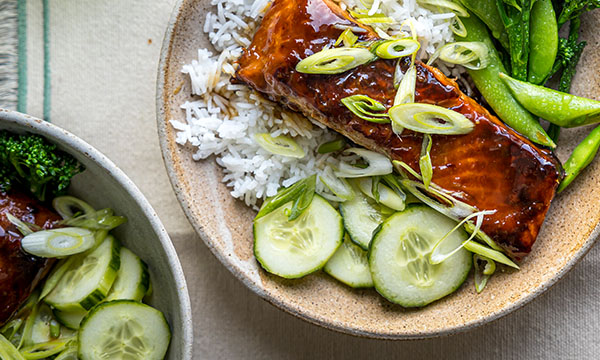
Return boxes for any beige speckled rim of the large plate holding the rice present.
[156,0,600,340]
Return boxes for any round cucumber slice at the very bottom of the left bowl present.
[79,300,171,360]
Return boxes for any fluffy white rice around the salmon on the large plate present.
[171,0,454,208]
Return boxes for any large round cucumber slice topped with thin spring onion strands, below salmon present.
[369,205,472,307]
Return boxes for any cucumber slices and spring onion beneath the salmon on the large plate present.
[254,147,518,307]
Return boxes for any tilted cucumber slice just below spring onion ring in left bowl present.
[45,236,121,311]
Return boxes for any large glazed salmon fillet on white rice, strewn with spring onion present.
[236,0,563,259]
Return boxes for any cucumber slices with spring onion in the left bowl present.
[0,196,171,360]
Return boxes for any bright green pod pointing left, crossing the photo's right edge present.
[500,73,600,128]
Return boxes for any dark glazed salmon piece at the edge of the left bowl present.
[0,191,61,325]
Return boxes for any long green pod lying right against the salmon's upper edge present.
[461,16,556,148]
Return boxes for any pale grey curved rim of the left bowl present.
[0,109,194,360]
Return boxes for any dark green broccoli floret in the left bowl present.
[0,131,83,201]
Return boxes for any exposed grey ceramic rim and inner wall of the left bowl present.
[0,109,193,360]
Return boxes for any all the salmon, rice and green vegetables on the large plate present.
[172,0,600,307]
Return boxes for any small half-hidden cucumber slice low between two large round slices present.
[323,234,373,288]
